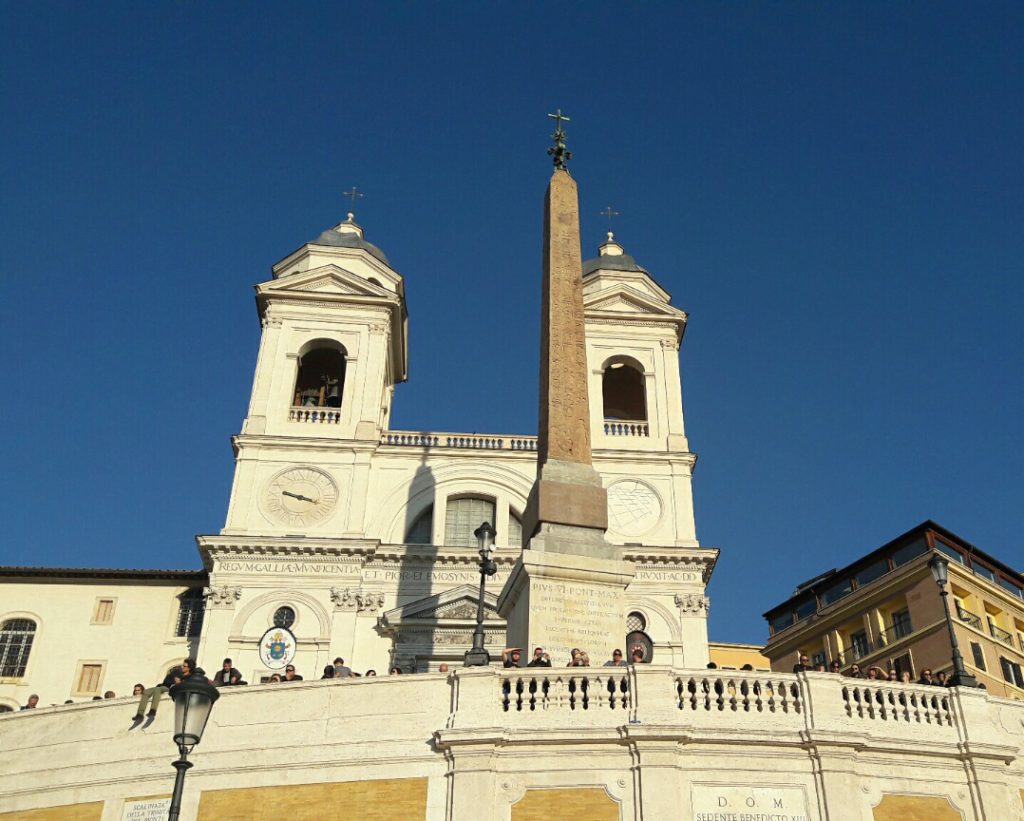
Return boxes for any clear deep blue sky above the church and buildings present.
[0,2,1024,642]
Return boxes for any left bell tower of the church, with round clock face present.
[222,213,409,536]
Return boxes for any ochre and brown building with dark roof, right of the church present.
[764,521,1024,699]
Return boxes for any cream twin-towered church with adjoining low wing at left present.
[0,210,718,709]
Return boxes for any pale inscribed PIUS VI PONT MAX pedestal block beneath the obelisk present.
[498,548,635,667]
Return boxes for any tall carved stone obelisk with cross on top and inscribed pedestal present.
[498,111,633,666]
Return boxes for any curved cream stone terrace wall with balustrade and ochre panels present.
[0,665,1024,821]
